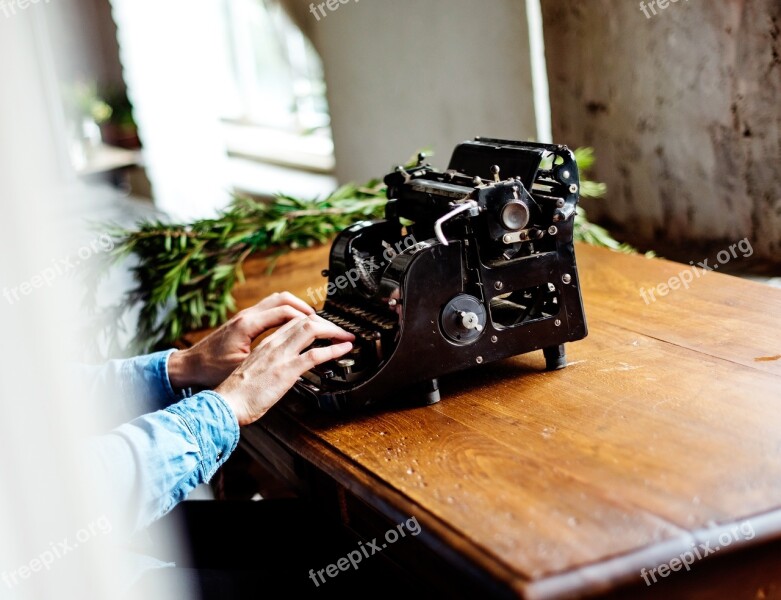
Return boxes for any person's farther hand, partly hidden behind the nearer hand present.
[168,292,315,389]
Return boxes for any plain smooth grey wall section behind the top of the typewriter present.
[288,0,536,181]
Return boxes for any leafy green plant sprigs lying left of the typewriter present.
[110,182,386,352]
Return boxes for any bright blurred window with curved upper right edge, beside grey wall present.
[222,0,333,173]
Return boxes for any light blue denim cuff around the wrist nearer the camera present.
[166,391,240,482]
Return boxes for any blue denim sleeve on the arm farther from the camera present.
[78,350,182,423]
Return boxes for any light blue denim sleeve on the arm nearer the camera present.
[87,391,239,533]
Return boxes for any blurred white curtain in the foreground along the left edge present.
[0,9,137,600]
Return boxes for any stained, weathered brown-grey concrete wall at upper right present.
[542,0,781,262]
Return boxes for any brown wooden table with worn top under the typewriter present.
[181,245,781,599]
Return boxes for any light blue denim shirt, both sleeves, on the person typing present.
[85,350,239,534]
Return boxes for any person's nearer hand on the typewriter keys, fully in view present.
[214,314,355,427]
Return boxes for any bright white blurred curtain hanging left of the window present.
[111,0,230,219]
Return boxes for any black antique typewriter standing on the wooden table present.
[294,138,586,410]
